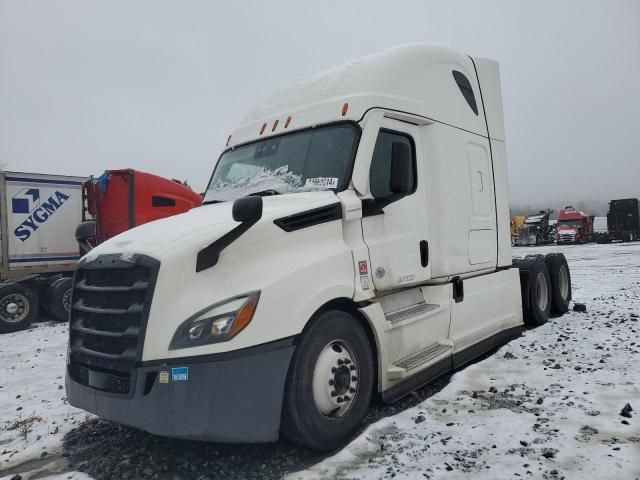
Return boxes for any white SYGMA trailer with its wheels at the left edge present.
[0,171,85,333]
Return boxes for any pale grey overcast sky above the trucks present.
[0,0,640,208]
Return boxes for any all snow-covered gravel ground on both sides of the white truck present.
[0,243,640,480]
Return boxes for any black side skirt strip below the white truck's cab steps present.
[380,326,523,403]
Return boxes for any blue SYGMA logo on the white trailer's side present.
[11,188,70,242]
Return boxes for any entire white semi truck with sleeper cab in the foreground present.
[66,45,571,449]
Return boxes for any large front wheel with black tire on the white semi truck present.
[281,310,374,450]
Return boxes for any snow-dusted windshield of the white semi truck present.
[204,123,359,204]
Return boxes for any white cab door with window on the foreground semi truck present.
[362,118,431,291]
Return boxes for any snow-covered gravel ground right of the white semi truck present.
[290,244,640,480]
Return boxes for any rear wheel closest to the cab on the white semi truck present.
[513,255,553,327]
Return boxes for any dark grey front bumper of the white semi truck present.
[65,339,295,443]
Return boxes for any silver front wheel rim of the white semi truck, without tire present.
[313,340,360,418]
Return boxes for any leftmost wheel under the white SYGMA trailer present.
[0,283,39,333]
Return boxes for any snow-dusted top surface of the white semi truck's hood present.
[83,191,338,261]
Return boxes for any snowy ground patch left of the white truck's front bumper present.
[0,322,89,479]
